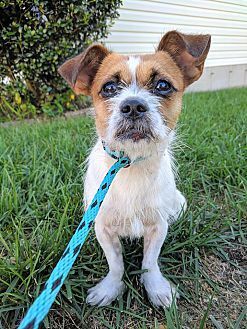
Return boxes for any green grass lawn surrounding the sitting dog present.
[0,89,247,329]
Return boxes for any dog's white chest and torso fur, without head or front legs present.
[84,141,185,237]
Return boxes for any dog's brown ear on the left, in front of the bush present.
[58,44,109,95]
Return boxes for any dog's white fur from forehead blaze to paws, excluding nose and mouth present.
[84,57,186,306]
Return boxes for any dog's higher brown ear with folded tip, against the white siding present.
[157,31,211,87]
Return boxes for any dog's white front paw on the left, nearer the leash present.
[86,276,124,306]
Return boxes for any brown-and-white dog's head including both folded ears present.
[59,31,210,155]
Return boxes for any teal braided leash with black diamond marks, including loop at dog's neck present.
[18,144,132,329]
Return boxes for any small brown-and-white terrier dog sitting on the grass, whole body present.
[59,31,211,306]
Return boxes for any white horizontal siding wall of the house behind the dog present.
[106,0,247,90]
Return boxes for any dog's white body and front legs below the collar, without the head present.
[85,141,185,306]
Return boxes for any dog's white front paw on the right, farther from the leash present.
[141,272,178,307]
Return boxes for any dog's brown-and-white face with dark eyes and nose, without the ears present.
[92,52,183,145]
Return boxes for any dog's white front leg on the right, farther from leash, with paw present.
[141,221,175,306]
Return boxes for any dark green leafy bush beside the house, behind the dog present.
[0,0,121,119]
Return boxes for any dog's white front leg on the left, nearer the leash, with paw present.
[86,218,124,306]
